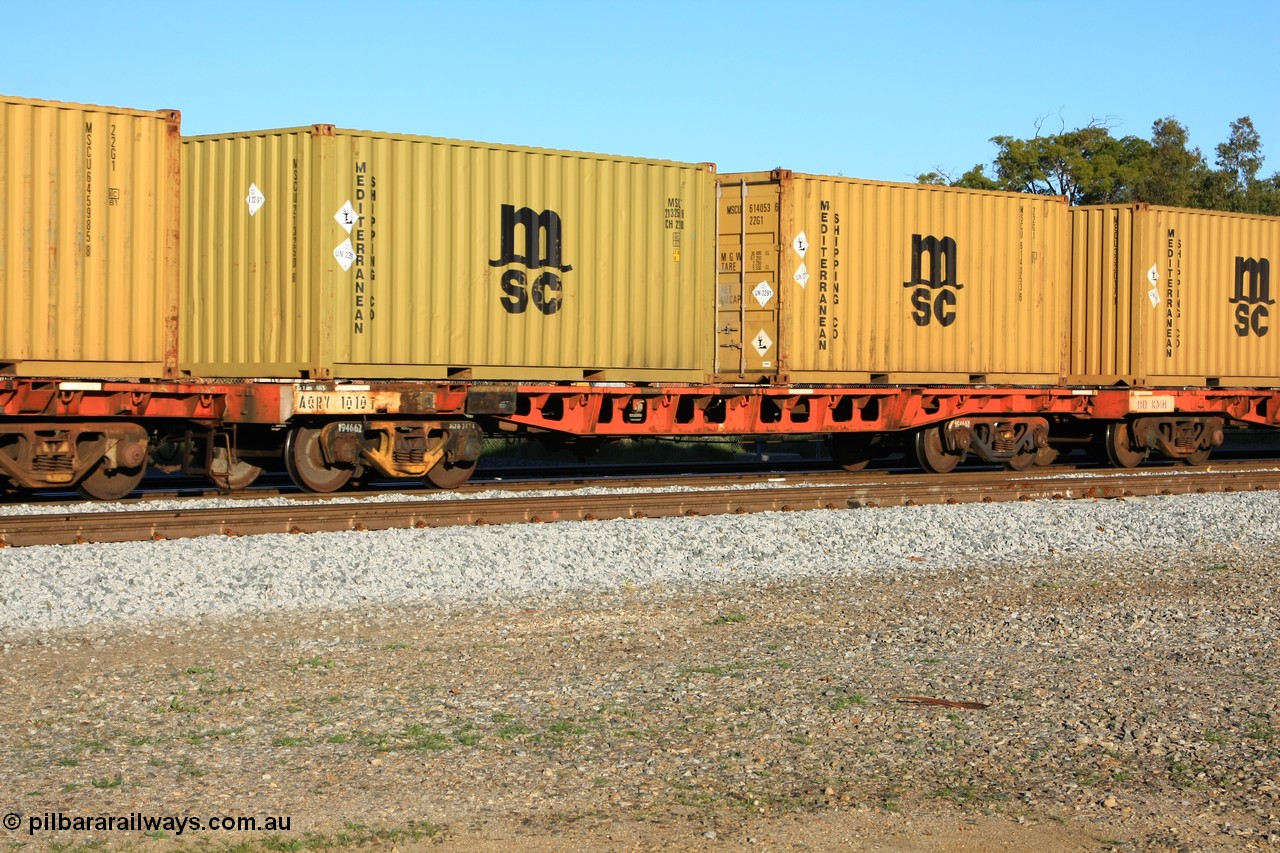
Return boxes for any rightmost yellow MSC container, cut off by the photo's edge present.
[1071,205,1280,387]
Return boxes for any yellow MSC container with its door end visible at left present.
[716,170,1069,384]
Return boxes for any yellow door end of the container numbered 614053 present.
[716,181,781,382]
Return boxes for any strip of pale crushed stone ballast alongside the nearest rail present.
[0,492,1264,635]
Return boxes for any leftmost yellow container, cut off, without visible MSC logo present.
[0,96,180,379]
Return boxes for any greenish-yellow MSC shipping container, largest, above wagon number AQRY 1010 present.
[182,124,716,380]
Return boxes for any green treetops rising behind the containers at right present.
[916,115,1280,215]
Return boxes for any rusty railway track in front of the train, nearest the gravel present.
[0,462,1280,547]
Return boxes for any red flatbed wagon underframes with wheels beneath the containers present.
[0,379,1280,500]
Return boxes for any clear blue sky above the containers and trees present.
[0,0,1280,181]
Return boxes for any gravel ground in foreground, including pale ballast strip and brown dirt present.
[0,493,1280,850]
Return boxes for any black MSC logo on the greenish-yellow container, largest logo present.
[489,205,573,316]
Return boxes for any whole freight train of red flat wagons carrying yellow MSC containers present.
[0,97,1280,500]
